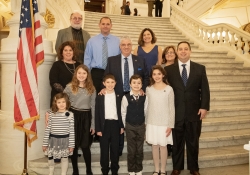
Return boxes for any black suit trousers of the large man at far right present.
[172,121,202,171]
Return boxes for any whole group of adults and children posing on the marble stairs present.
[43,12,210,175]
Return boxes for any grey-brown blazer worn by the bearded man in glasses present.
[55,26,90,52]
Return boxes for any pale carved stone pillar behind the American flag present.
[0,0,55,174]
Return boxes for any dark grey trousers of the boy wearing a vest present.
[126,123,146,173]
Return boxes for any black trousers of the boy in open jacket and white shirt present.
[100,120,120,175]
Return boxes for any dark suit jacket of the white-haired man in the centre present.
[104,54,149,96]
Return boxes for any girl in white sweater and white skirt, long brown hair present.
[146,65,175,175]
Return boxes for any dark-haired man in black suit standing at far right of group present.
[165,41,210,175]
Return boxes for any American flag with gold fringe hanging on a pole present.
[14,0,44,146]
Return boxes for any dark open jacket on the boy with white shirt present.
[95,94,124,132]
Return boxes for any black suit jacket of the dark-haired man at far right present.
[164,61,210,122]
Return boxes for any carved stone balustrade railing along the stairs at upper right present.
[170,0,250,66]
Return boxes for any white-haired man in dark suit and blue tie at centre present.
[102,36,149,155]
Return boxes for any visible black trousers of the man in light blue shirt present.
[91,68,105,94]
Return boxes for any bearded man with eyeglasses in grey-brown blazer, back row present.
[55,11,90,63]
